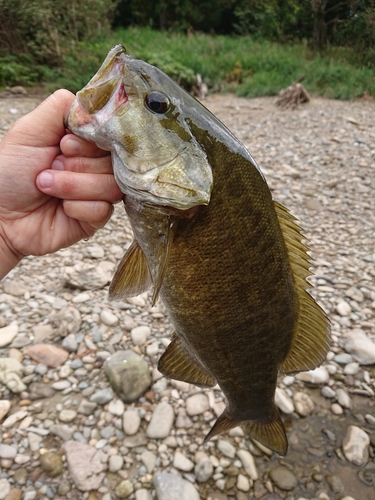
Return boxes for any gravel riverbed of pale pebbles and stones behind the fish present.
[0,95,375,500]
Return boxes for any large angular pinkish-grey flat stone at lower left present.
[64,441,107,491]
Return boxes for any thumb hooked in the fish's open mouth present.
[6,89,75,147]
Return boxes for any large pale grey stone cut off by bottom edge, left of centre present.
[154,472,200,500]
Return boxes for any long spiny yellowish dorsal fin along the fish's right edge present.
[274,202,330,373]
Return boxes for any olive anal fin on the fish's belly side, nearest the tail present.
[158,334,216,387]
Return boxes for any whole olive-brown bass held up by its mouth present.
[66,45,330,455]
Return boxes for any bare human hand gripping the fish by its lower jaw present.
[0,90,122,279]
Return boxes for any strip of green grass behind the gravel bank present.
[4,28,375,99]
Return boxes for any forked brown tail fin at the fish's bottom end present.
[204,406,288,456]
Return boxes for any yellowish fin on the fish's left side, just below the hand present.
[109,240,152,300]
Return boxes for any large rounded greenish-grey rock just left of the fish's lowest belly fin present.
[104,350,151,403]
